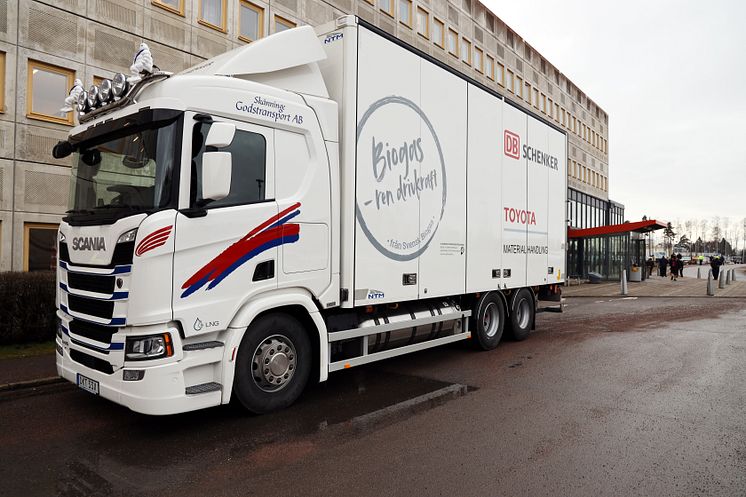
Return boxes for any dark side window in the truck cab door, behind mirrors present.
[192,126,267,209]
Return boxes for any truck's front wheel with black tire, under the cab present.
[233,313,313,414]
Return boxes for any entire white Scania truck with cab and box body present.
[54,16,567,414]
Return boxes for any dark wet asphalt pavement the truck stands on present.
[0,298,746,497]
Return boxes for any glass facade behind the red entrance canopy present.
[567,188,630,279]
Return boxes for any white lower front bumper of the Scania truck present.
[56,327,224,415]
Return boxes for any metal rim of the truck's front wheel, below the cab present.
[251,335,298,392]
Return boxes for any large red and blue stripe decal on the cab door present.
[181,202,300,298]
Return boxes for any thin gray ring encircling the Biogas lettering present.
[355,95,446,261]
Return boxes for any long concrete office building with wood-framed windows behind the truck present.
[0,0,618,271]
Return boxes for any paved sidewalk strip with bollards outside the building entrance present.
[562,265,746,298]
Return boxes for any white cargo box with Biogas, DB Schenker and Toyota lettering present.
[320,18,567,306]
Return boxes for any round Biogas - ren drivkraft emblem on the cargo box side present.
[355,96,447,261]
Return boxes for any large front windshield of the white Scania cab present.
[66,113,181,224]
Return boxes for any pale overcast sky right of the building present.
[483,0,746,229]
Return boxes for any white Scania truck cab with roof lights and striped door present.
[55,27,340,414]
